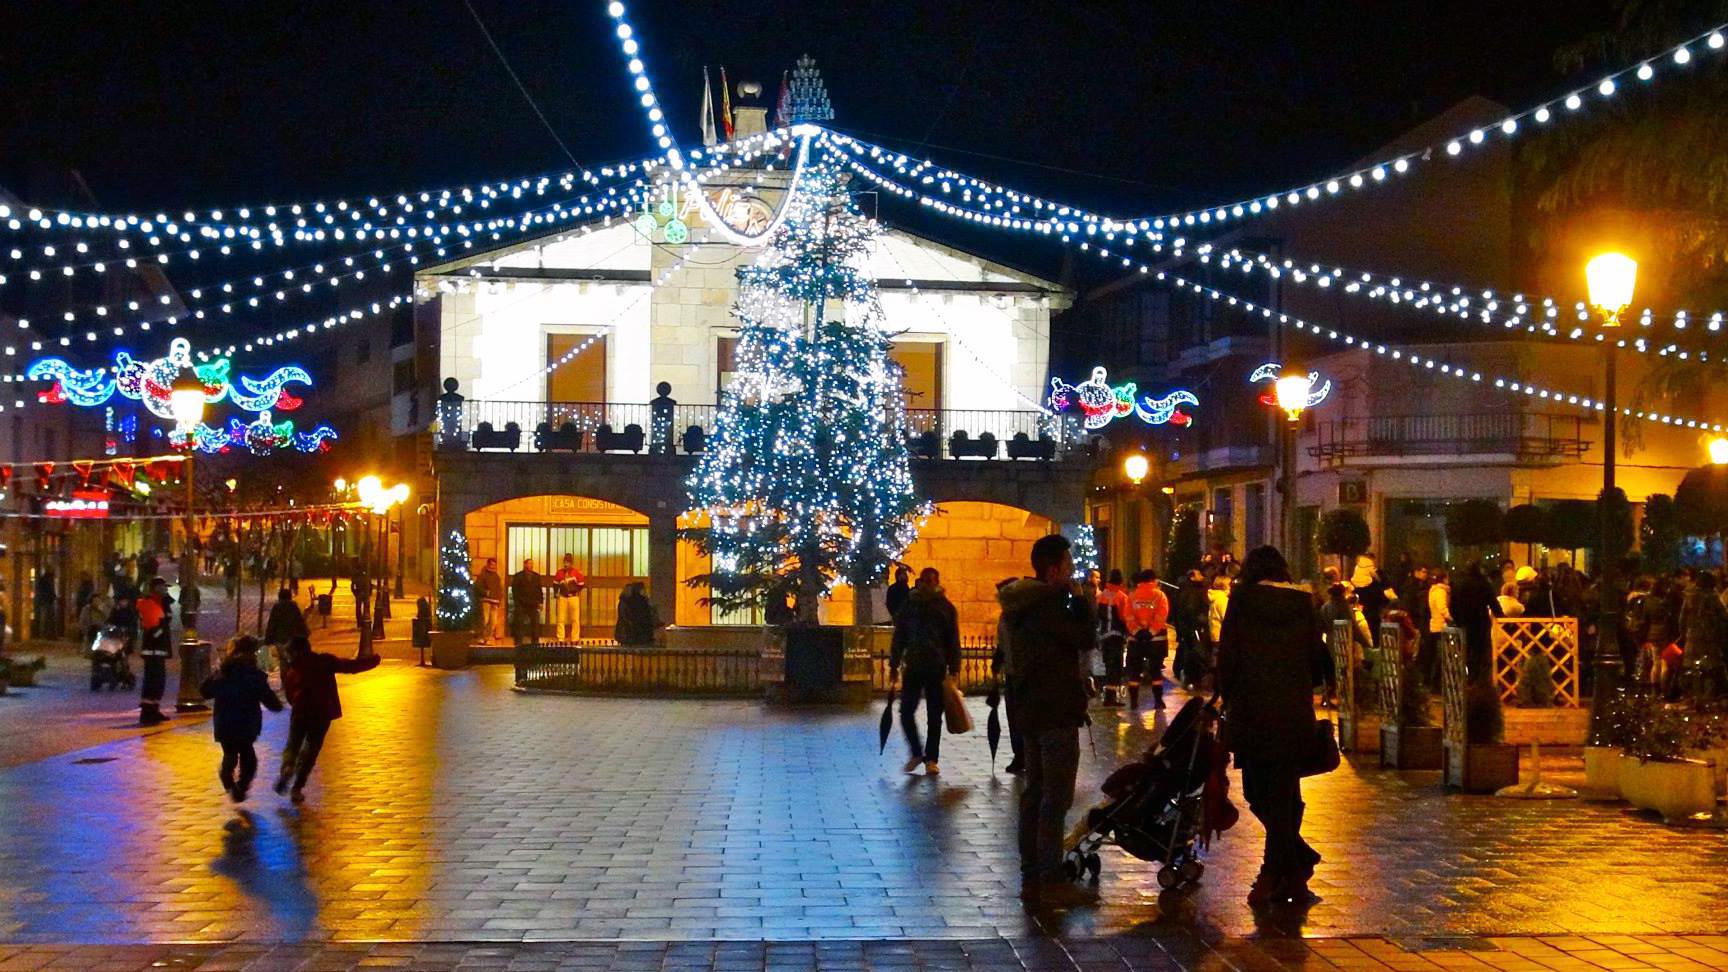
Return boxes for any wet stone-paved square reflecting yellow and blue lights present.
[0,662,1728,969]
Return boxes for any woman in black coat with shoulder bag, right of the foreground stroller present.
[1218,547,1325,908]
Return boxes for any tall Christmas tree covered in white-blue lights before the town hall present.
[684,163,928,621]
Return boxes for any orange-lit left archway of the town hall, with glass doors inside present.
[463,495,650,638]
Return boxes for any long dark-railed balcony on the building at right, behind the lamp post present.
[1308,412,1590,467]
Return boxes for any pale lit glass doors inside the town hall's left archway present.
[505,522,648,638]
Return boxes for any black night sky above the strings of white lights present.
[0,0,1638,223]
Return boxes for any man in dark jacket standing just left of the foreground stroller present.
[997,534,1092,901]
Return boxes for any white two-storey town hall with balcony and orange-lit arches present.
[415,154,1092,636]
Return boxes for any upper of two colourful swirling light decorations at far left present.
[26,337,313,420]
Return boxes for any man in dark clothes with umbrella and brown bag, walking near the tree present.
[888,567,961,777]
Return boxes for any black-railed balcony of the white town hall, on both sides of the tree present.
[437,393,1089,462]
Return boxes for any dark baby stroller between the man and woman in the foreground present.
[1063,695,1239,889]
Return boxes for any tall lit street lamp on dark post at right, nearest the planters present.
[1585,253,1638,745]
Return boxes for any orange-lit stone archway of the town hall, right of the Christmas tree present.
[902,500,1058,638]
